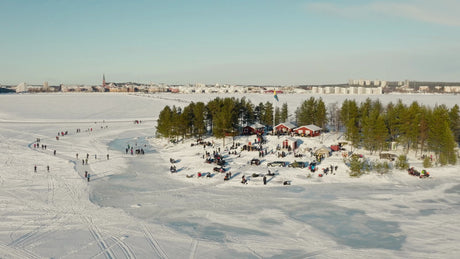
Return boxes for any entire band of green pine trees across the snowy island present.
[157,97,460,165]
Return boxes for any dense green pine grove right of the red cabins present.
[339,99,460,165]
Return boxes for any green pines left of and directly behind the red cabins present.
[157,97,327,138]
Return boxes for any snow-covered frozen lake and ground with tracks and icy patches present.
[0,94,460,258]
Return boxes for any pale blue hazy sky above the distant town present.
[0,0,460,85]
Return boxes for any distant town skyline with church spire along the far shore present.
[0,76,460,95]
